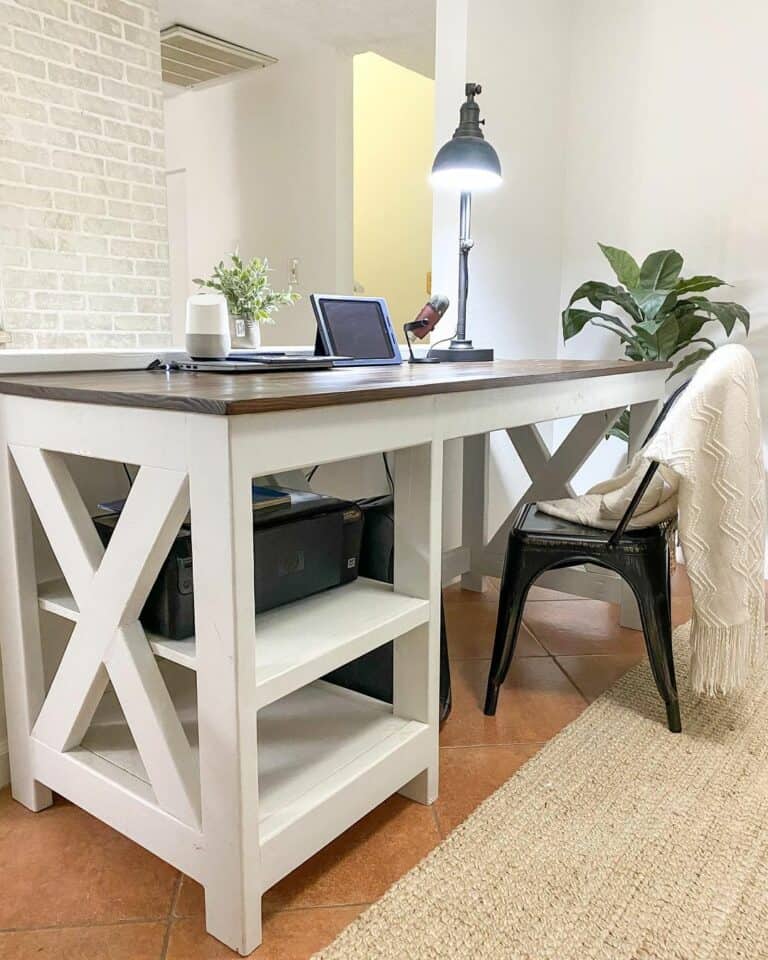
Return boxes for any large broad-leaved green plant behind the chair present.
[562,243,749,440]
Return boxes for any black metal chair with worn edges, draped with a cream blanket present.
[485,381,690,733]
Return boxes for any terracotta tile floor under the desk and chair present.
[0,569,690,960]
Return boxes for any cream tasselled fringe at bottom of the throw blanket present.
[690,602,766,697]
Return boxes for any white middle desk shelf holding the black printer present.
[38,578,429,708]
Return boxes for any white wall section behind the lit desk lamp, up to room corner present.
[433,0,569,546]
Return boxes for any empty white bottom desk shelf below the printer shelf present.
[75,680,433,889]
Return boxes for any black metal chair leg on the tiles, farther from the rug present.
[483,539,539,717]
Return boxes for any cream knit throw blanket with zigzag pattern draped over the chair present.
[538,344,765,696]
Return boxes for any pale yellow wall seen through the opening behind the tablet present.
[353,53,434,339]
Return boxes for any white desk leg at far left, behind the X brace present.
[0,441,53,811]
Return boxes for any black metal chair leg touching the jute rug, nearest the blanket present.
[620,564,682,733]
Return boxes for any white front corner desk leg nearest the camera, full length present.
[188,417,262,955]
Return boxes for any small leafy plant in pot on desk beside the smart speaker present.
[193,250,300,347]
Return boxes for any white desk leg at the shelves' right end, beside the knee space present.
[394,441,443,803]
